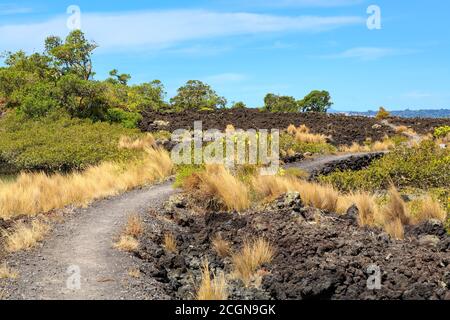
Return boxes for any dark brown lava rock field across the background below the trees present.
[140,109,395,145]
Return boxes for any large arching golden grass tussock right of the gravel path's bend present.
[183,165,250,211]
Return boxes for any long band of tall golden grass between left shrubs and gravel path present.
[0,149,173,219]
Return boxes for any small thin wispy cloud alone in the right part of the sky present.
[322,47,417,61]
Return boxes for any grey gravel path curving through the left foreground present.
[5,183,175,300]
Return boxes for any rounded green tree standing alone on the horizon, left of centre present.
[170,80,227,111]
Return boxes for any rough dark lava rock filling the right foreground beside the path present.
[137,194,450,300]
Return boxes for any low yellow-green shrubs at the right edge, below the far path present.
[319,141,450,191]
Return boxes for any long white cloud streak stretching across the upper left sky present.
[0,10,364,50]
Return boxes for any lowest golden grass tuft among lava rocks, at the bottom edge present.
[196,260,228,300]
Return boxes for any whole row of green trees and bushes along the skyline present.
[0,30,332,128]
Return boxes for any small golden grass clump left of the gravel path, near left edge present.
[4,220,50,252]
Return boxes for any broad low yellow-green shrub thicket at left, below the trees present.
[0,113,140,172]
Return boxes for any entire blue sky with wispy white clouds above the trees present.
[0,0,450,110]
